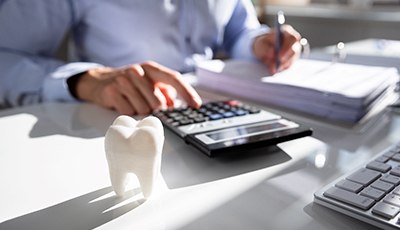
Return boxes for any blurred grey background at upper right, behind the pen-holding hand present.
[253,0,400,48]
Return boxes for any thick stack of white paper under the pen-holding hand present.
[196,60,399,123]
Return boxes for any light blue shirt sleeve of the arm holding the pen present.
[224,0,270,60]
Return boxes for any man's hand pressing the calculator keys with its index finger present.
[76,62,201,115]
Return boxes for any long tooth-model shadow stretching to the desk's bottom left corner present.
[0,187,144,230]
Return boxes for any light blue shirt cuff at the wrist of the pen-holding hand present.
[232,25,270,61]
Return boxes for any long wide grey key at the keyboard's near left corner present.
[324,187,375,210]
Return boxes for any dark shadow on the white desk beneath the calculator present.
[161,130,292,189]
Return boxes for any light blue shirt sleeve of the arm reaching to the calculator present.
[0,0,98,108]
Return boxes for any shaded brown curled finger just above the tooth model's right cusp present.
[115,74,151,114]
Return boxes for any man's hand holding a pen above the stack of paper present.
[253,25,301,74]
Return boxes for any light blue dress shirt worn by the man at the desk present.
[0,0,268,108]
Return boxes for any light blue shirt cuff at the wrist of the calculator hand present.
[43,62,102,102]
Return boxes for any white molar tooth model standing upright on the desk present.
[104,115,164,199]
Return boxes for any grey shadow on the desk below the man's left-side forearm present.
[0,103,118,139]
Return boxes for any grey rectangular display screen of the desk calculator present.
[206,122,286,141]
